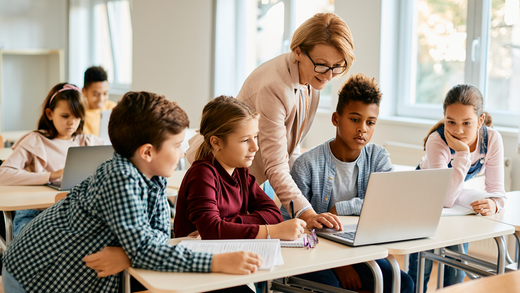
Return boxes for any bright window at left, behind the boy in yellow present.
[69,0,132,92]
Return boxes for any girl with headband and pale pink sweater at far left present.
[0,83,103,236]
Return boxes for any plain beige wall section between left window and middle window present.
[132,0,214,128]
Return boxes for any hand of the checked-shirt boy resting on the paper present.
[211,251,262,275]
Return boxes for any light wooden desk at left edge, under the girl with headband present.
[0,186,60,251]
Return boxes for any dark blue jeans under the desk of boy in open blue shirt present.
[296,259,414,293]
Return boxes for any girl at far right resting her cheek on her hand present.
[408,84,505,292]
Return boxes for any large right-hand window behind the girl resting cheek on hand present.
[397,0,520,126]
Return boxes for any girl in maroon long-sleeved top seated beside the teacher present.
[174,96,305,240]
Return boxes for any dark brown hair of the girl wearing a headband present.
[36,82,85,139]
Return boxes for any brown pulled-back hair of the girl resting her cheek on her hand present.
[423,84,493,150]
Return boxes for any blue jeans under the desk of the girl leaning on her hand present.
[408,243,468,293]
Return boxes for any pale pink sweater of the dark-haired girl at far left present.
[0,131,103,185]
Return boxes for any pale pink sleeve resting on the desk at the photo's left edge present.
[0,147,51,185]
